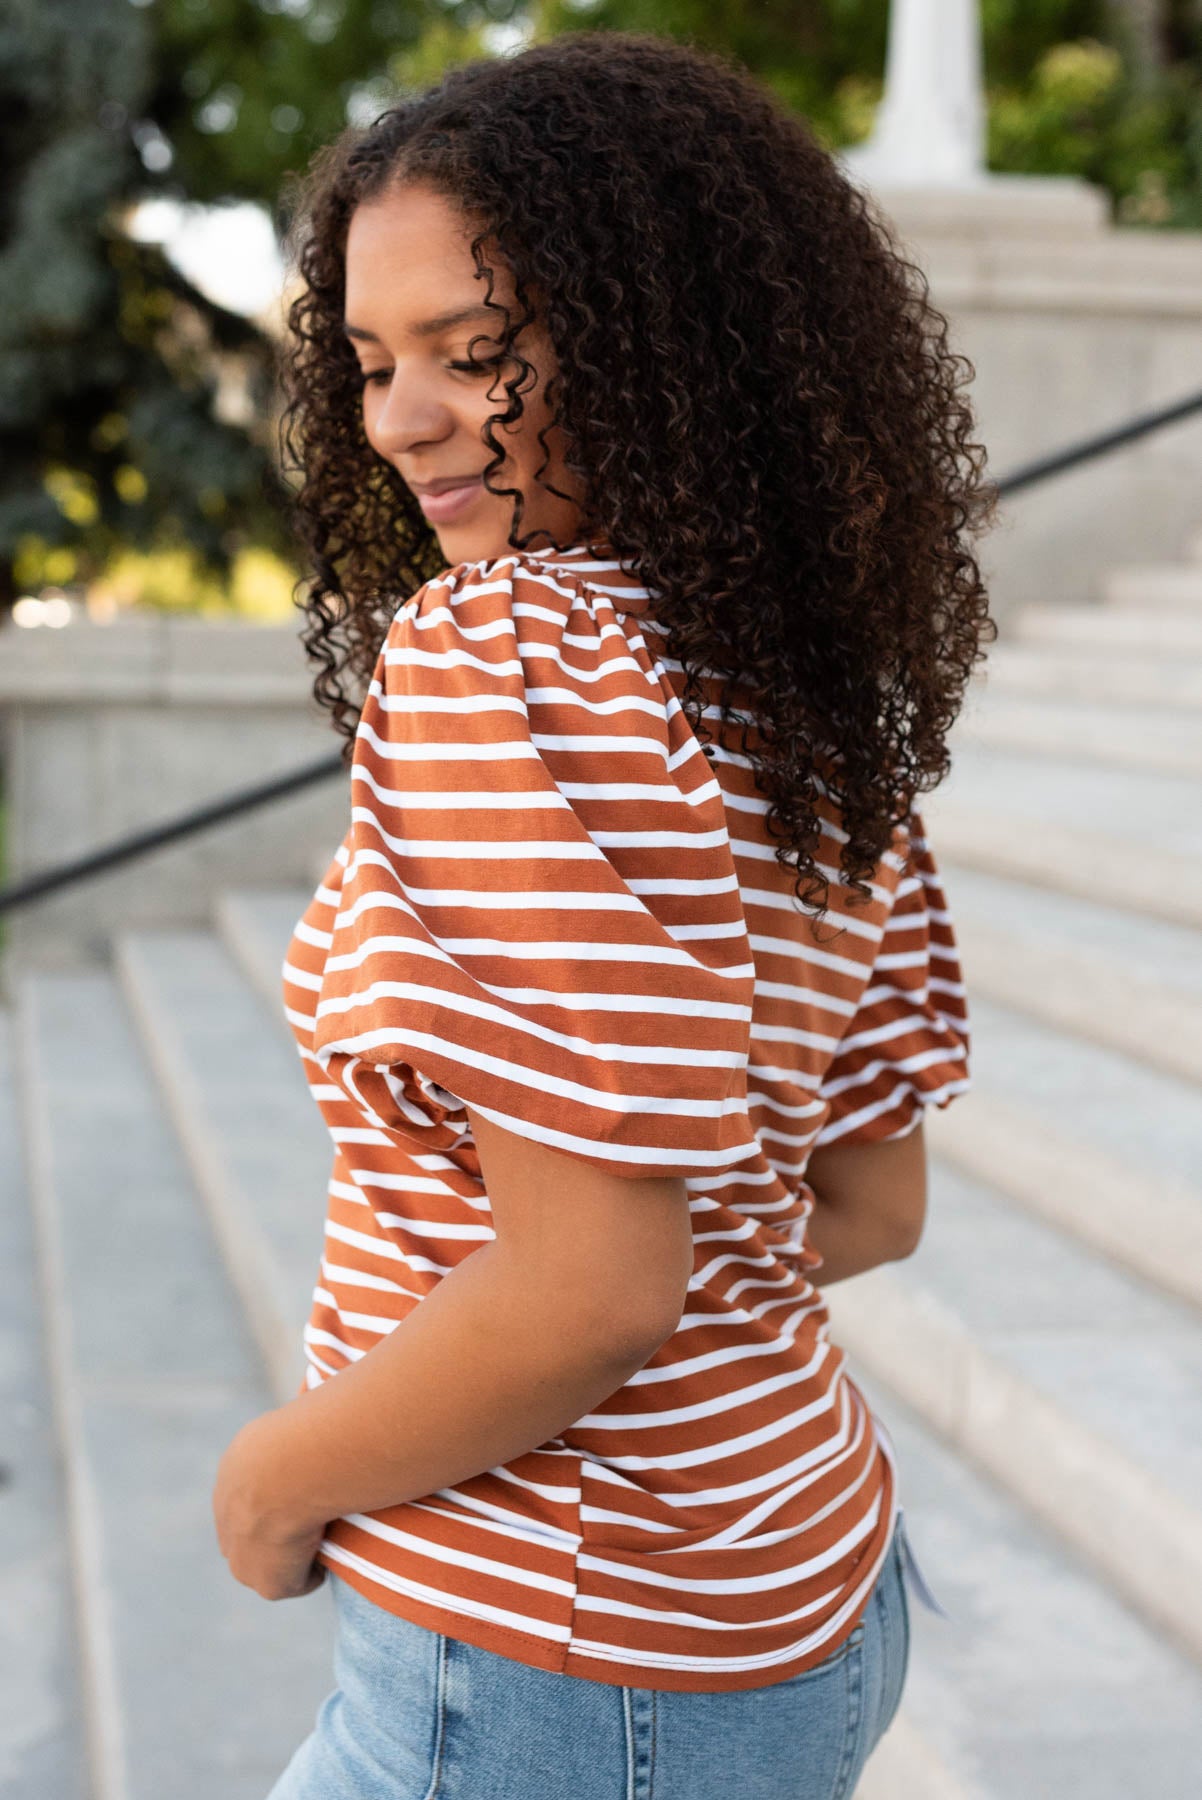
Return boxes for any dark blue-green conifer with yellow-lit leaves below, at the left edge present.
[0,0,296,607]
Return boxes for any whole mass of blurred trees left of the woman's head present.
[0,0,515,608]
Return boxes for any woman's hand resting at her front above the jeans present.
[212,1413,326,1600]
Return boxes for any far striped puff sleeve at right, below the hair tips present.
[815,810,972,1145]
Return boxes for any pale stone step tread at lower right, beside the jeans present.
[849,1368,1202,1800]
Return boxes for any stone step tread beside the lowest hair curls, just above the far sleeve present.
[923,806,1202,931]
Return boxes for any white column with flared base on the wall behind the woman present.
[840,0,986,187]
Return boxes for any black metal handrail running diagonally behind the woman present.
[0,378,1202,916]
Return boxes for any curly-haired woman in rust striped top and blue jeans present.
[214,32,991,1800]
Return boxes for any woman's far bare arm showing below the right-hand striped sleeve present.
[806,1120,927,1287]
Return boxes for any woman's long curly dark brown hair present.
[281,31,997,916]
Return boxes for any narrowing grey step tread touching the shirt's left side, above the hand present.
[115,929,333,1402]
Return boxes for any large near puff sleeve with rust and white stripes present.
[313,554,754,1177]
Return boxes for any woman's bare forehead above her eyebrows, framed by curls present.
[345,185,513,328]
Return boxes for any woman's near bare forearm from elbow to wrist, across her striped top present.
[256,1240,653,1525]
